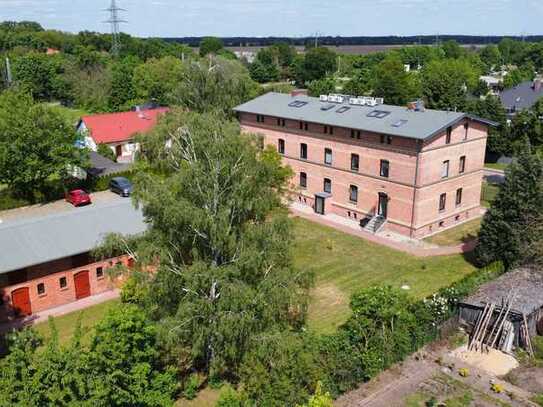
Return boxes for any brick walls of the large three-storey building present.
[239,112,487,238]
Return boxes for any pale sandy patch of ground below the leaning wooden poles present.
[451,345,519,376]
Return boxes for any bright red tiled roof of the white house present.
[81,107,169,144]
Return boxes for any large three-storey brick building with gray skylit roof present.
[235,93,493,238]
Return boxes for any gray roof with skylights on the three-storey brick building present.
[234,92,474,140]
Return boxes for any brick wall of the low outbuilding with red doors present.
[0,254,132,321]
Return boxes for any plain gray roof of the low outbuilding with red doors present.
[0,199,147,273]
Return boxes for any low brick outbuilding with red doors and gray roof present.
[0,200,146,321]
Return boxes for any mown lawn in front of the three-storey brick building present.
[293,218,475,333]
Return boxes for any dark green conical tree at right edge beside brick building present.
[475,140,543,267]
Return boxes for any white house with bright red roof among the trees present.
[77,107,169,162]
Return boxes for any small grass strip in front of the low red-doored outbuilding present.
[34,300,119,344]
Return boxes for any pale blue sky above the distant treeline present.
[0,0,543,37]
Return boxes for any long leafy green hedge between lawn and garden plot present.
[240,263,505,407]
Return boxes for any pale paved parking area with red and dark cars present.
[0,191,130,223]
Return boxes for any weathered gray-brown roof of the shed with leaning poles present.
[462,268,543,316]
